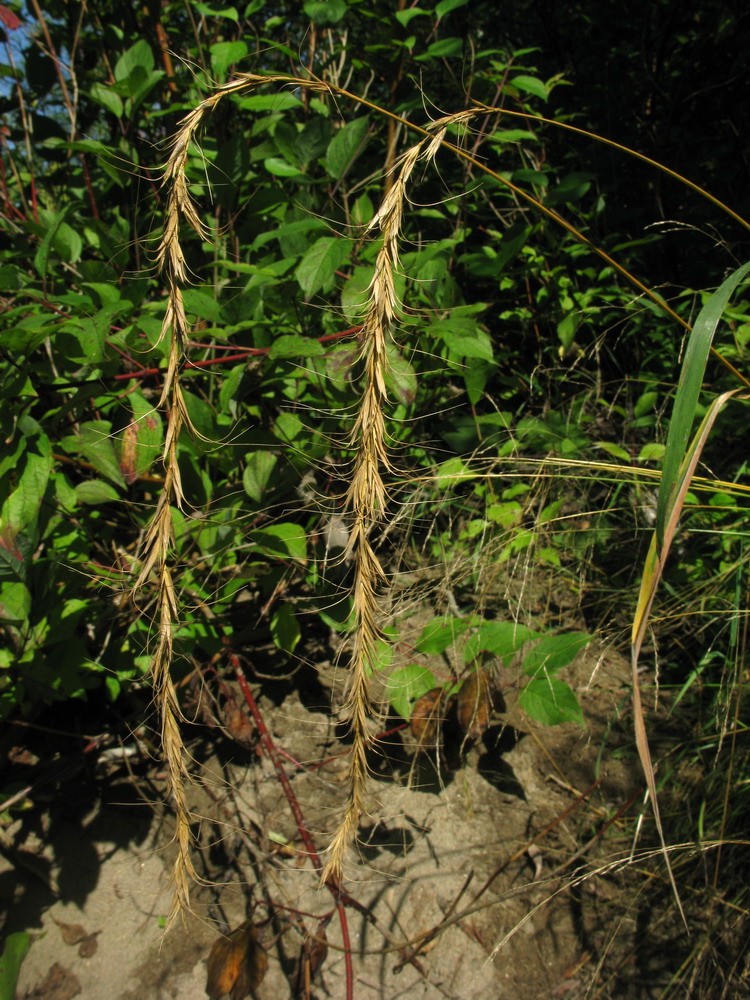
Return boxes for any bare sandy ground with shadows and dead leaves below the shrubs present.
[0,640,638,1000]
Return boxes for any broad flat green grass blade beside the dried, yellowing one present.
[656,262,750,547]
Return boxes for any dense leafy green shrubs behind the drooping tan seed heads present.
[0,0,750,995]
